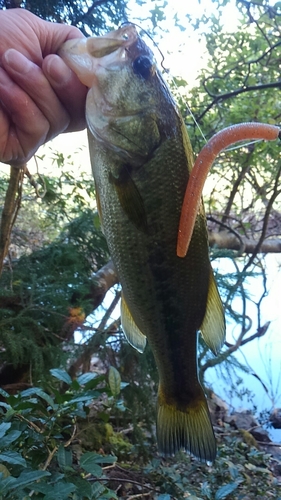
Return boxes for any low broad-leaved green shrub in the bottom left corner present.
[0,369,121,500]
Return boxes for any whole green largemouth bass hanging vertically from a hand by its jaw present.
[59,24,225,464]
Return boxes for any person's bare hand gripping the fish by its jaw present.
[0,9,87,166]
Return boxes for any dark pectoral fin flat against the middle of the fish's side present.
[109,165,147,232]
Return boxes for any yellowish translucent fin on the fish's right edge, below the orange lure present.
[200,267,225,354]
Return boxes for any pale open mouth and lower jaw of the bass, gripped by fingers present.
[58,24,139,87]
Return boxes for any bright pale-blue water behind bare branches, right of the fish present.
[206,254,281,443]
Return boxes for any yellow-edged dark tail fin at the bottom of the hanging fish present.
[156,384,214,465]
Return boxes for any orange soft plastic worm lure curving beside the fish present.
[177,123,281,257]
